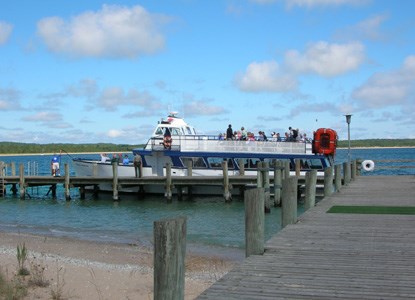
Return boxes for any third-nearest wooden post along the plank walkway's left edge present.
[281,177,298,227]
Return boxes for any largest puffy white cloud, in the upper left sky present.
[37,5,165,58]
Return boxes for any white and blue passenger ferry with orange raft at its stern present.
[73,112,337,193]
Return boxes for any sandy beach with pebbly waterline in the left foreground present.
[0,232,237,300]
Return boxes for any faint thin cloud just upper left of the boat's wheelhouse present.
[98,87,161,111]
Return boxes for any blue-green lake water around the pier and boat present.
[0,148,415,257]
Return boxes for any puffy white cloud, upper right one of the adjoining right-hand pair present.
[285,41,365,77]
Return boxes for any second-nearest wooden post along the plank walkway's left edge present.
[244,188,265,257]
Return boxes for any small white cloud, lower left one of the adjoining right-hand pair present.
[235,61,297,92]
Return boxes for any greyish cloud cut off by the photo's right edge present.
[352,55,415,108]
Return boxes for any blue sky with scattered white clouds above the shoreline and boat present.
[0,0,415,144]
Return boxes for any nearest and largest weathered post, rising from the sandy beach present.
[154,217,186,300]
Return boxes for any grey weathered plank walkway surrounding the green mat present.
[198,176,415,299]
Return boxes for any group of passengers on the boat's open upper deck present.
[219,124,310,142]
